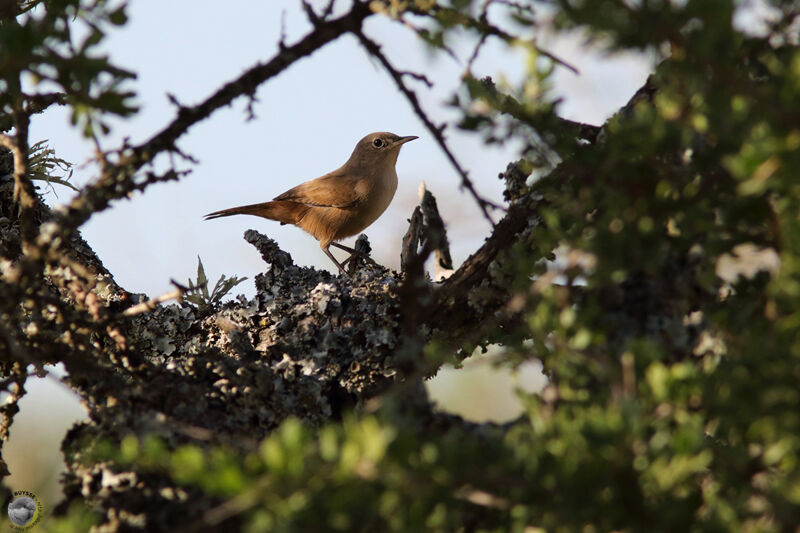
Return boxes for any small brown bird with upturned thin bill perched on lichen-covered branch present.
[205,131,417,276]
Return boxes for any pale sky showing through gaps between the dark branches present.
[5,0,664,508]
